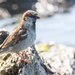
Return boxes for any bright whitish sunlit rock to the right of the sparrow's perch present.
[38,42,75,75]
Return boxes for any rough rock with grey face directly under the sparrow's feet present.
[0,47,46,75]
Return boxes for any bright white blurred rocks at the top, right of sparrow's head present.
[35,0,75,17]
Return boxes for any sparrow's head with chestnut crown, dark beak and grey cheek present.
[22,10,39,29]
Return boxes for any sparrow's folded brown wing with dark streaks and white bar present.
[1,27,27,48]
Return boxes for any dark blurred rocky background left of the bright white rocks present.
[0,0,36,18]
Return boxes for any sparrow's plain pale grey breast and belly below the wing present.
[13,30,36,52]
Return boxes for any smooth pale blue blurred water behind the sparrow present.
[0,6,75,46]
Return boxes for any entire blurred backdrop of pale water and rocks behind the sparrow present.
[0,0,75,46]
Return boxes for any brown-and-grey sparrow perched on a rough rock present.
[0,10,39,62]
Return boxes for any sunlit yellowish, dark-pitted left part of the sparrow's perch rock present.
[0,53,19,75]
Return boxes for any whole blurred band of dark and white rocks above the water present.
[0,0,75,18]
